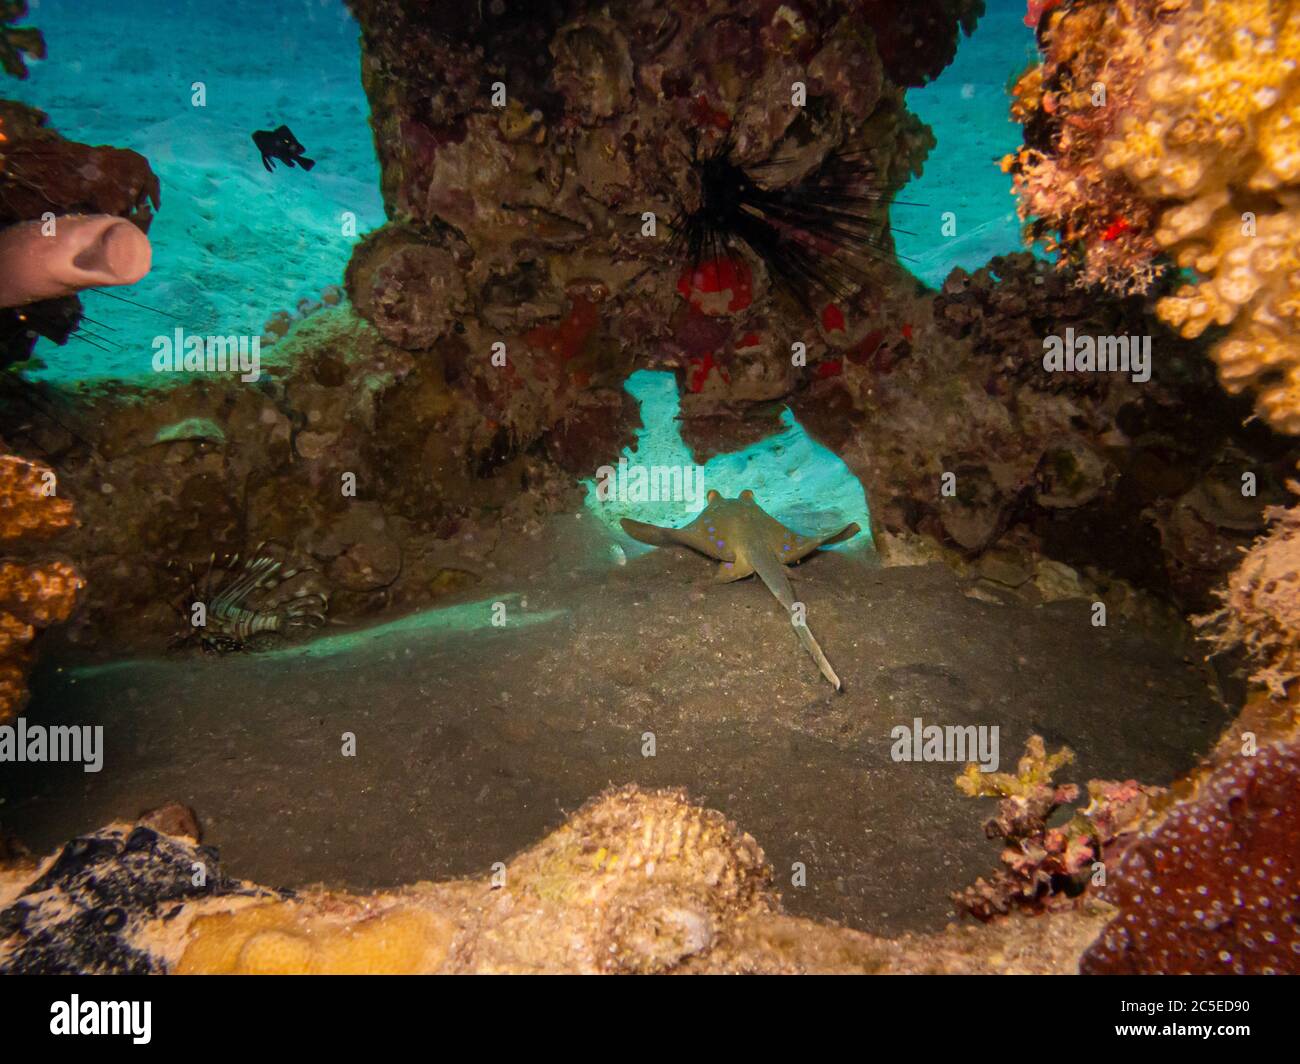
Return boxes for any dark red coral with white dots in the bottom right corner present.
[1080,738,1300,974]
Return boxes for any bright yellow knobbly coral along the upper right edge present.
[1104,0,1300,433]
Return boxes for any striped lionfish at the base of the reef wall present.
[172,542,329,653]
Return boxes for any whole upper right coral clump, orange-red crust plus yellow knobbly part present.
[1004,0,1300,434]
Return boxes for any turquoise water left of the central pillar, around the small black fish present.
[10,0,384,381]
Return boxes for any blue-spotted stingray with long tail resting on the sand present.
[621,490,861,691]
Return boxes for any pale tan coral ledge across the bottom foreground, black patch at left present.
[0,787,1104,974]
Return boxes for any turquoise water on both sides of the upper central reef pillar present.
[3,0,1034,381]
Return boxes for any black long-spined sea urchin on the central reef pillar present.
[670,137,905,313]
